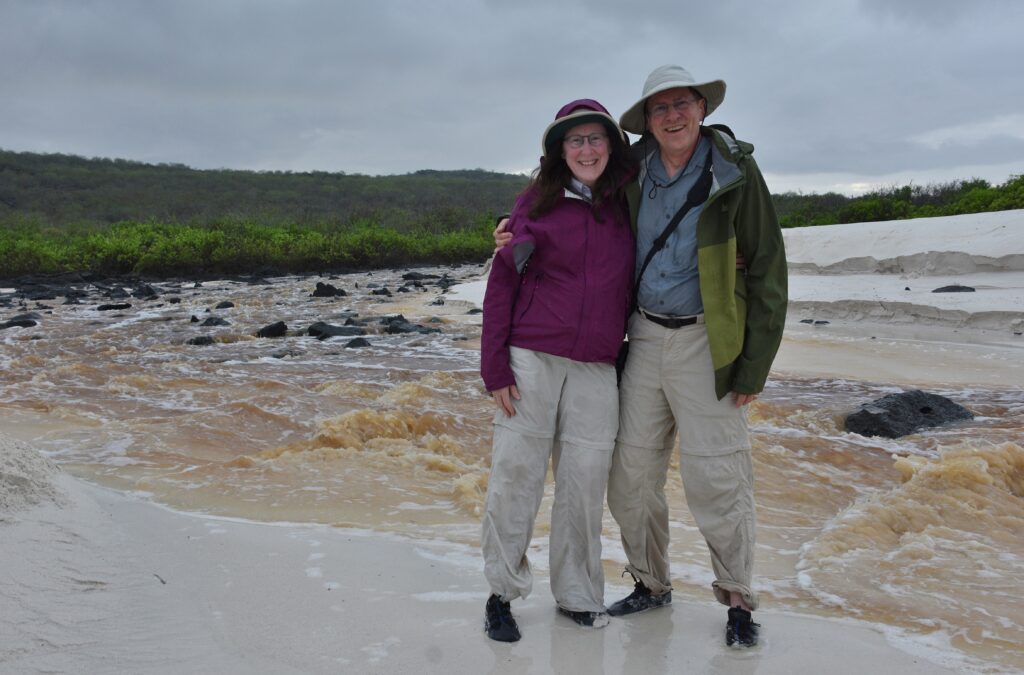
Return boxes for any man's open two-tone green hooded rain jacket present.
[626,127,787,398]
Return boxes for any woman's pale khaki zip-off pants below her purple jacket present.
[482,347,618,611]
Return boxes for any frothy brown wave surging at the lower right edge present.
[797,442,1024,658]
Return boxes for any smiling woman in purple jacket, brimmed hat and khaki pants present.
[480,99,635,642]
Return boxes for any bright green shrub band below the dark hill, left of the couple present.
[0,217,494,278]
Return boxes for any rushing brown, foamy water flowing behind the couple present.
[0,267,1024,670]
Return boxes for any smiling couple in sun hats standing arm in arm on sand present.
[480,66,786,646]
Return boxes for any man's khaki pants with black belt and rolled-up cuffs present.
[608,314,758,609]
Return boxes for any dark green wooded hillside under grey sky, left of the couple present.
[0,150,527,228]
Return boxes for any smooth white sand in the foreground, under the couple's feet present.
[0,446,952,675]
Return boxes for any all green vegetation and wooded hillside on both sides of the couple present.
[0,150,1024,279]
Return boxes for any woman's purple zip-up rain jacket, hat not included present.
[480,191,634,391]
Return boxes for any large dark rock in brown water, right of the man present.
[846,389,974,438]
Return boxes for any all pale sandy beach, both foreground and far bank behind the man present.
[0,211,1024,674]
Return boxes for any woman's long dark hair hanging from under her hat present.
[526,126,637,222]
